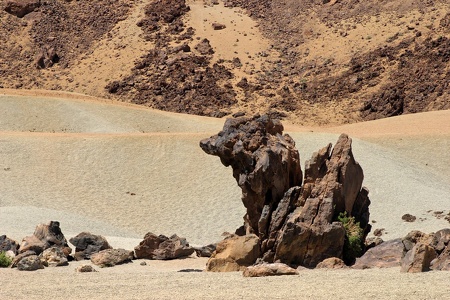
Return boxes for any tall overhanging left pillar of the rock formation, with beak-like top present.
[200,115,302,235]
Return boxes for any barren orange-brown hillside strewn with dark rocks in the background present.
[0,0,450,125]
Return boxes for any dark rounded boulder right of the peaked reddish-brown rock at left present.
[69,232,112,260]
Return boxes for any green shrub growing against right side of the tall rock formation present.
[338,212,364,265]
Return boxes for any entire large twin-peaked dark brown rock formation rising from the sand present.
[200,115,371,267]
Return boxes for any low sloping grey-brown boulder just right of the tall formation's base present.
[352,239,404,269]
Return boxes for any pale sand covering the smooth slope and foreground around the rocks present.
[0,94,450,299]
